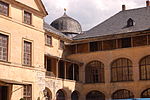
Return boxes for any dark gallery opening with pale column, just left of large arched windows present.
[69,64,79,81]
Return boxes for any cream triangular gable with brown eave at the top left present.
[15,0,47,15]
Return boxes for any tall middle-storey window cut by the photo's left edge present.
[0,34,8,61]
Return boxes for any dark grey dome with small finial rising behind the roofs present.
[51,9,82,38]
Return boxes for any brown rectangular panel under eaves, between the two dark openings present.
[103,40,116,50]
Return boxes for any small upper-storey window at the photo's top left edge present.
[0,1,9,16]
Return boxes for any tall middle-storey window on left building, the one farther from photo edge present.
[24,41,32,66]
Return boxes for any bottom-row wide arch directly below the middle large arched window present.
[112,89,134,99]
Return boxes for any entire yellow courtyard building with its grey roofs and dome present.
[0,0,150,100]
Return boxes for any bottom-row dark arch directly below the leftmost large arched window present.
[86,91,105,100]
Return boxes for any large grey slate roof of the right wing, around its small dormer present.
[73,7,150,40]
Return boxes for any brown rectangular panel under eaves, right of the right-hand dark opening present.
[133,35,147,46]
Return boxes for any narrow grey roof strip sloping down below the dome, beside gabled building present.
[44,22,71,40]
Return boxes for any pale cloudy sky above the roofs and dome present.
[42,0,146,31]
